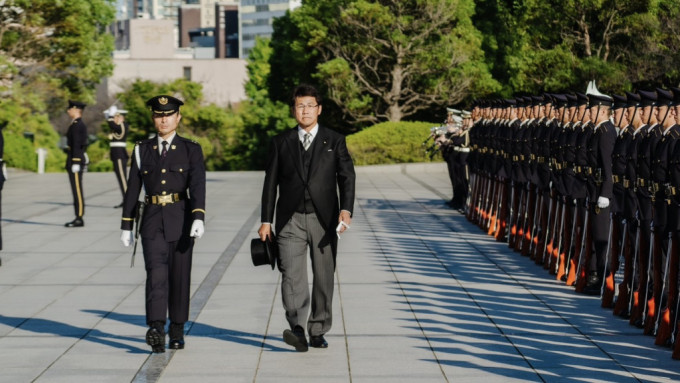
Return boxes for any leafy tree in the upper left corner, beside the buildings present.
[0,0,115,111]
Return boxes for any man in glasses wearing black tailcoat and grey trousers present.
[258,85,355,351]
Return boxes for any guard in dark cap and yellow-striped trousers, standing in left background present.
[64,100,87,227]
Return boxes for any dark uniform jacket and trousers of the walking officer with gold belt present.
[121,135,205,325]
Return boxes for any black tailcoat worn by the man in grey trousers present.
[261,126,355,235]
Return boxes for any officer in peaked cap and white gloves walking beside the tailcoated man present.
[121,96,205,352]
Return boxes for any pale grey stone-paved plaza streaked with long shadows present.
[0,163,680,383]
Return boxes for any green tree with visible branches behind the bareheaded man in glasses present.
[291,0,498,124]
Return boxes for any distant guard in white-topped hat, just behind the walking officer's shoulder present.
[104,105,130,208]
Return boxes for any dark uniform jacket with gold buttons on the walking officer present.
[121,135,205,242]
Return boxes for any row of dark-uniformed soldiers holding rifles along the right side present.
[464,82,680,359]
